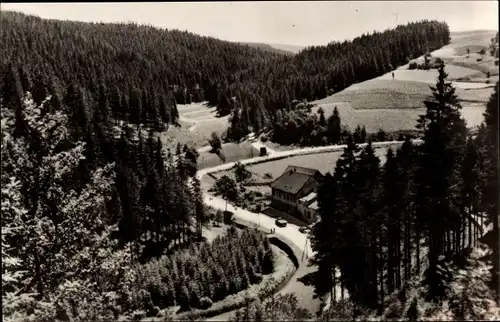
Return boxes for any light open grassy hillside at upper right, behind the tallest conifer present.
[313,31,498,132]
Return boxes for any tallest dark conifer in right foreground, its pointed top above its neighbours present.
[416,65,466,299]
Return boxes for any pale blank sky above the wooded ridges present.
[1,0,498,46]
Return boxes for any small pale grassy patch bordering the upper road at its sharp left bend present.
[198,142,259,169]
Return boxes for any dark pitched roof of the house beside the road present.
[271,165,321,195]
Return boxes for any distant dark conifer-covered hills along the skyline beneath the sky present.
[0,12,449,139]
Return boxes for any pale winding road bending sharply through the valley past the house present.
[196,140,422,320]
